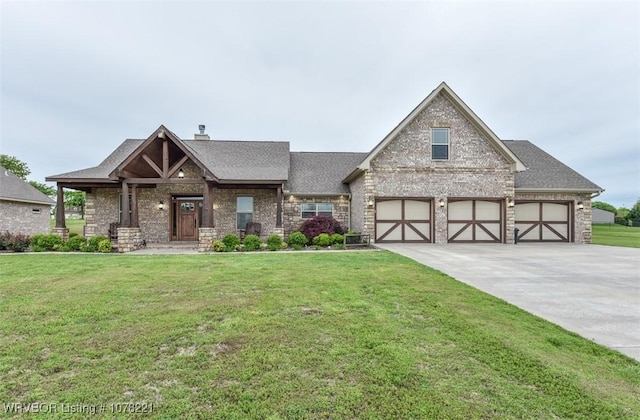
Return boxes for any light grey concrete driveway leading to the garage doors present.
[376,243,640,360]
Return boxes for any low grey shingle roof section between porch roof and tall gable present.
[289,152,367,194]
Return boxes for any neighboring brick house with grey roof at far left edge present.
[0,166,55,236]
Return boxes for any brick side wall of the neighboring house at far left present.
[0,200,51,236]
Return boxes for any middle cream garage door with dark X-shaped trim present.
[447,199,502,243]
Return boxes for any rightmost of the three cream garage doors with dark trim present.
[515,201,571,242]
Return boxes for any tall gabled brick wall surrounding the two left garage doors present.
[360,94,514,243]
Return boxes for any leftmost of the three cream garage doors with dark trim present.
[375,199,432,242]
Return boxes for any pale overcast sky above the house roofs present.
[0,0,640,208]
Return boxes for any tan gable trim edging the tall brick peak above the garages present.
[345,82,525,181]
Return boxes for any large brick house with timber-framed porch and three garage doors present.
[47,83,603,251]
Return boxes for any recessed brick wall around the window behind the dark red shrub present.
[282,195,350,238]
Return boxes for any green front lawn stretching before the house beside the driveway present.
[0,251,640,419]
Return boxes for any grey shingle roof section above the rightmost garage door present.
[503,140,603,192]
